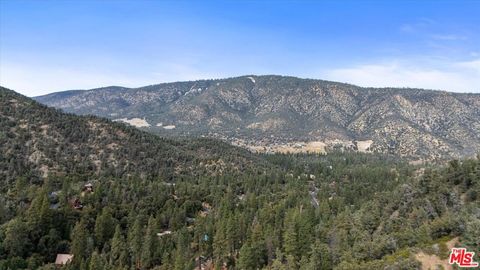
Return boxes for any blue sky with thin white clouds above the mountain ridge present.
[0,0,480,96]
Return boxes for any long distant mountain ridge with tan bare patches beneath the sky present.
[35,76,480,159]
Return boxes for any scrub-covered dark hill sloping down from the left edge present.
[0,88,270,188]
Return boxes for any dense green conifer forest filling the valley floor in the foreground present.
[0,153,480,269]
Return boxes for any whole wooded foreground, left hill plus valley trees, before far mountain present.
[0,89,480,270]
